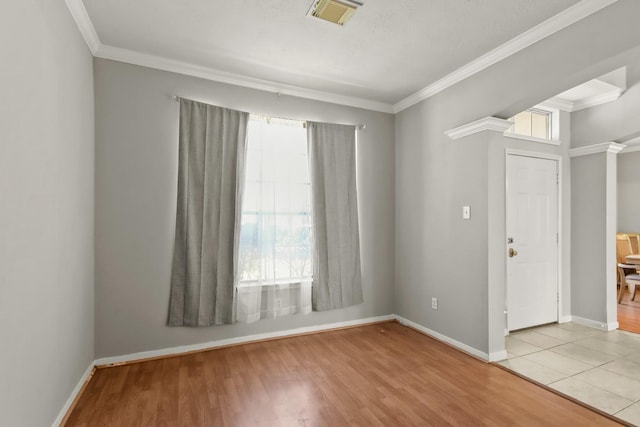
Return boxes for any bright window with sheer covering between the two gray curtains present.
[238,116,312,287]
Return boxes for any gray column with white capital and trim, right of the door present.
[569,142,625,331]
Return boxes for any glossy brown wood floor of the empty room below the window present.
[66,322,617,427]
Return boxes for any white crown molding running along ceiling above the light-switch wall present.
[393,0,618,113]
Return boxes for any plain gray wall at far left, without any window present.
[0,0,94,427]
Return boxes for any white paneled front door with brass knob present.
[507,155,558,331]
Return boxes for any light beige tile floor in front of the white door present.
[500,323,640,426]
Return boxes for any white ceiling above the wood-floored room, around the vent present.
[74,0,615,109]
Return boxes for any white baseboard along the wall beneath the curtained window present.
[94,314,396,366]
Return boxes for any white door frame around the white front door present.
[503,148,564,336]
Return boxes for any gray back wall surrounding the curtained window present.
[94,60,395,357]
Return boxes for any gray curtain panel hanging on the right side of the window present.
[307,122,362,311]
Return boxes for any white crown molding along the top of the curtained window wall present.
[95,44,393,113]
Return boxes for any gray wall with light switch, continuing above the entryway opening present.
[395,0,640,352]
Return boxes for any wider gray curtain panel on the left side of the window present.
[168,99,249,326]
